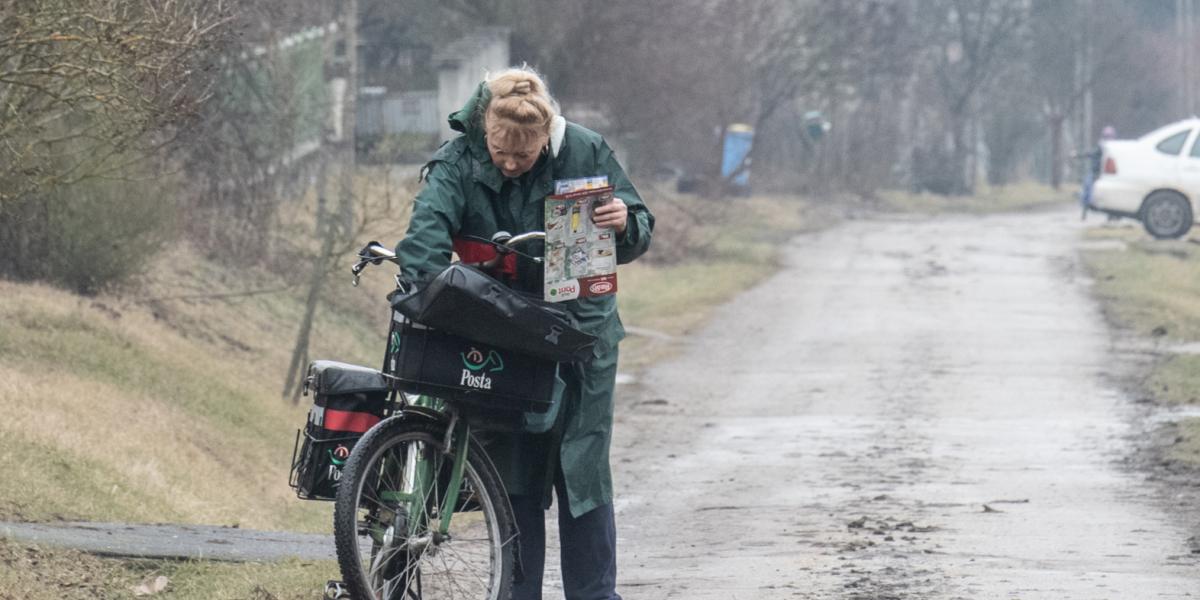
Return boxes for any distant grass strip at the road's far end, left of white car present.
[877,181,1079,215]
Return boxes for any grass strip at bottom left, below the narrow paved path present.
[0,540,337,600]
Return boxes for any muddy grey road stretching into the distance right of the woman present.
[613,212,1200,600]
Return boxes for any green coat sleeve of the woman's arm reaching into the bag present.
[396,161,467,281]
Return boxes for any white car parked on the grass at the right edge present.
[1088,118,1200,239]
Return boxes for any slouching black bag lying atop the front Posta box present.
[391,264,596,362]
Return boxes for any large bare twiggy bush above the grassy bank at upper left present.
[0,0,230,289]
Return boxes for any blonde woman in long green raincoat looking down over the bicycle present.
[396,68,654,600]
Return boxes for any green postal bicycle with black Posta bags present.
[292,232,594,600]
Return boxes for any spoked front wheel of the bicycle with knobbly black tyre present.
[334,419,516,600]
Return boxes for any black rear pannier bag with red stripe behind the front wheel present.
[288,360,389,500]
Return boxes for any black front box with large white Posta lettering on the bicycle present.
[385,311,558,417]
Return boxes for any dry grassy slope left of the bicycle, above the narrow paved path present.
[0,165,422,530]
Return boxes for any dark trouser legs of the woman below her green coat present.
[509,479,620,600]
